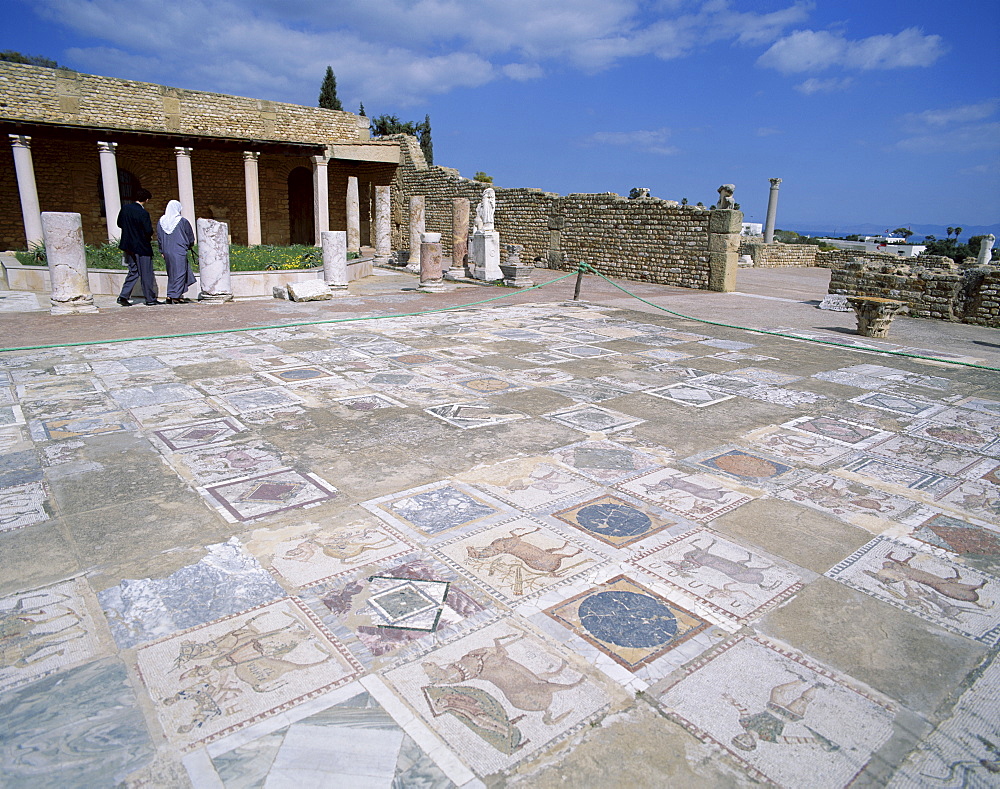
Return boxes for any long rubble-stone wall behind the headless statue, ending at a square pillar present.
[392,136,742,289]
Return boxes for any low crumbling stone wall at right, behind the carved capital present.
[830,255,1000,327]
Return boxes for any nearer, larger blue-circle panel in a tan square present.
[545,575,711,672]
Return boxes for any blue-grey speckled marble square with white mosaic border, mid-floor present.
[362,482,510,536]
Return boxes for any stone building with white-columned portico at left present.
[0,62,400,249]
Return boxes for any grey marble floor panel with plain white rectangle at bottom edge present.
[213,693,453,789]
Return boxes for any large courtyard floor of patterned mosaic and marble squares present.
[0,304,1000,789]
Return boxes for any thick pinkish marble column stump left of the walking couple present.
[41,211,97,315]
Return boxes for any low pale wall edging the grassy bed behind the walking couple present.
[0,257,373,299]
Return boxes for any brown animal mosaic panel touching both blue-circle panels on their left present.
[433,518,604,602]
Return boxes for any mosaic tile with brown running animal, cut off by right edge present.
[826,537,1000,646]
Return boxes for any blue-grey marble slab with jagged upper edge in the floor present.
[97,537,285,649]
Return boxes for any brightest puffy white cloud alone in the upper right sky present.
[757,27,945,74]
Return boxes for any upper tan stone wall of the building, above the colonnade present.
[0,62,368,145]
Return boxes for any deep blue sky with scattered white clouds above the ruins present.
[0,0,1000,232]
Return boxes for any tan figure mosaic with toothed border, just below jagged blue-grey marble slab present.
[136,599,361,751]
